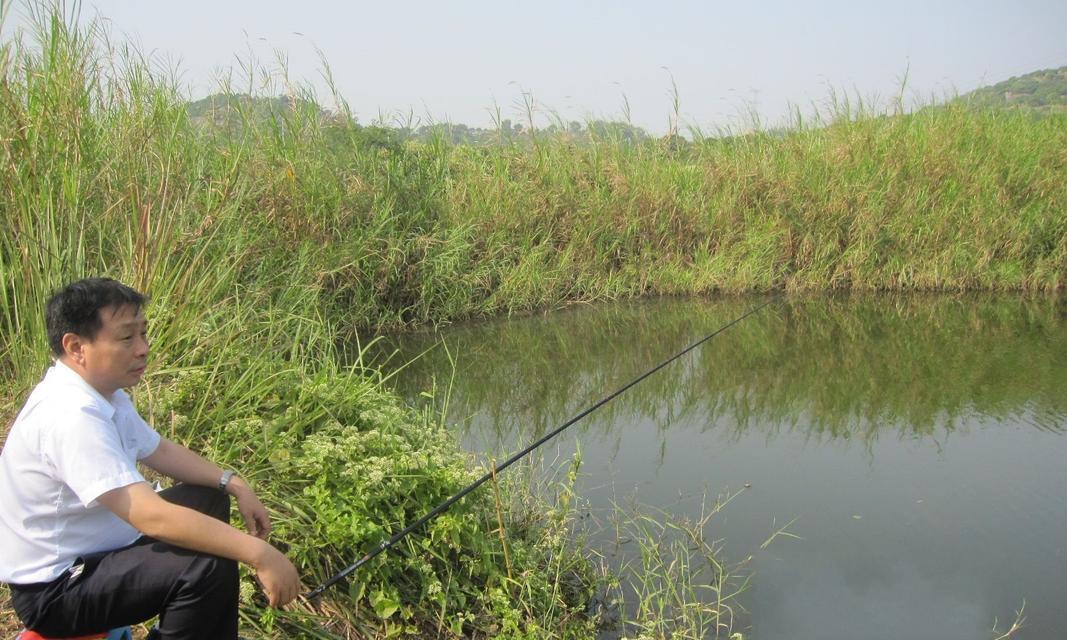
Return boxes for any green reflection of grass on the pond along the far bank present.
[384,294,1067,450]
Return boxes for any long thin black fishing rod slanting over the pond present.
[305,298,776,599]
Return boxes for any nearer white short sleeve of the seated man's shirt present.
[42,411,148,508]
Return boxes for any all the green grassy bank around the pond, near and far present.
[0,5,1067,637]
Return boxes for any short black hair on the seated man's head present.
[45,277,148,356]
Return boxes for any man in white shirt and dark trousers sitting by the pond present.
[0,278,300,640]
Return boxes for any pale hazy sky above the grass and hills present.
[7,0,1067,133]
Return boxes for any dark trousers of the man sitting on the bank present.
[11,484,238,640]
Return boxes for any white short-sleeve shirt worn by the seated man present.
[0,362,160,585]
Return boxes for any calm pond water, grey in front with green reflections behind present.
[373,295,1067,640]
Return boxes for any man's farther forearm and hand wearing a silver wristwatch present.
[141,437,271,540]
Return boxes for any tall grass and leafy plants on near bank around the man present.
[0,8,594,638]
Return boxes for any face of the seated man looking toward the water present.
[79,305,148,398]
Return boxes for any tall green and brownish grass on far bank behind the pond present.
[177,73,1067,334]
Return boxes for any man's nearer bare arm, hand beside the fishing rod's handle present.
[97,482,300,607]
